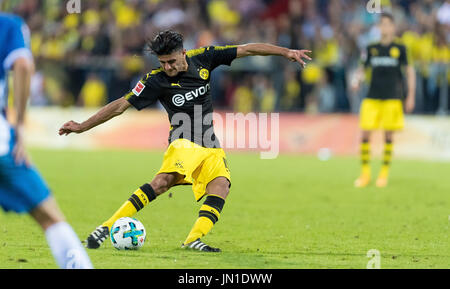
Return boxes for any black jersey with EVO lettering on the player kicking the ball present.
[124,45,237,148]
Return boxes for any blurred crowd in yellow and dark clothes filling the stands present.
[2,0,450,114]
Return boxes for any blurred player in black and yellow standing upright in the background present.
[352,13,416,187]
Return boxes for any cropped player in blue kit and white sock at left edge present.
[0,13,92,268]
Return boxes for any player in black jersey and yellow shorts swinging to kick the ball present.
[59,31,311,252]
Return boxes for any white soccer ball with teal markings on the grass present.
[110,217,146,250]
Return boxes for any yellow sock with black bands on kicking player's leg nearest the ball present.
[102,184,156,229]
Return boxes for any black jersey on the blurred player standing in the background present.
[363,41,408,99]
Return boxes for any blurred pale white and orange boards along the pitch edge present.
[21,107,450,161]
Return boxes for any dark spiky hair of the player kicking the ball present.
[149,30,183,55]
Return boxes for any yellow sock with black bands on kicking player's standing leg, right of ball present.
[183,196,225,245]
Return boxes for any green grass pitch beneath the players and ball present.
[0,149,450,268]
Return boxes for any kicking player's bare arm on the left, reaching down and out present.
[59,97,131,135]
